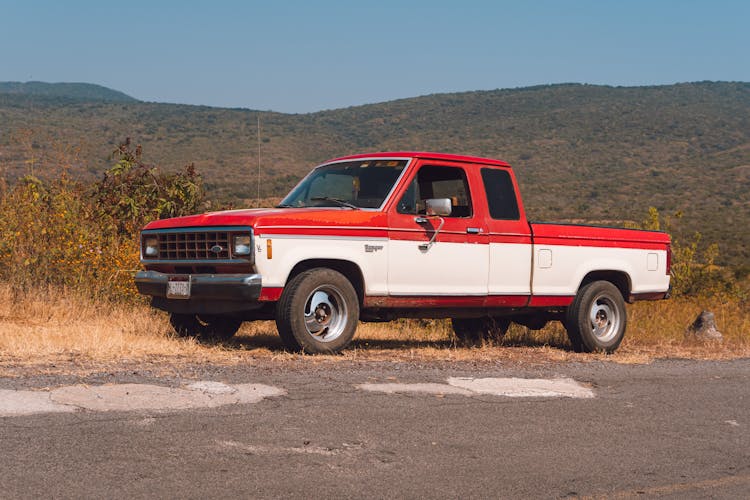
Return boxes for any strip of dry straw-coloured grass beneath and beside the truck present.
[0,286,750,374]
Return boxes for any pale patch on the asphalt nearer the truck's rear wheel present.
[357,377,594,399]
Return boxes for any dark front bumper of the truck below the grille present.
[135,271,262,302]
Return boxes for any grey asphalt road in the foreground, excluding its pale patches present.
[0,360,750,498]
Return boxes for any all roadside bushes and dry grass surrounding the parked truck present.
[0,141,750,367]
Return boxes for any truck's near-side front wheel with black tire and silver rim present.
[276,267,359,354]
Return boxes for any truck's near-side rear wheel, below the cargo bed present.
[565,281,628,353]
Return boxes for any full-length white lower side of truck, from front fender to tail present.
[256,235,669,296]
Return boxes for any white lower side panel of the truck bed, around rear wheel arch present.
[533,245,669,295]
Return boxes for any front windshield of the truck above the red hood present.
[279,160,406,209]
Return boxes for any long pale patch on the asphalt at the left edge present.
[0,382,286,416]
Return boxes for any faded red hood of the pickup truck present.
[144,208,386,234]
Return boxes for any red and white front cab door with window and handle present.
[388,160,489,296]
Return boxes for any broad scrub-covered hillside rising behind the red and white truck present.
[0,82,750,264]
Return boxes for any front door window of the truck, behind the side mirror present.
[397,165,473,217]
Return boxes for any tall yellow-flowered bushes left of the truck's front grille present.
[0,141,206,302]
